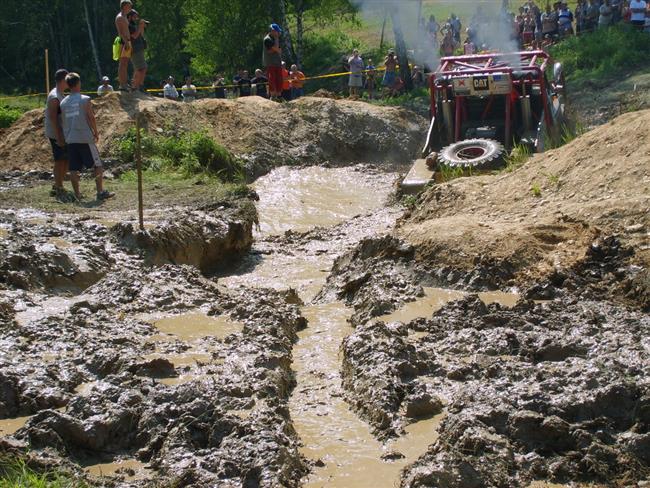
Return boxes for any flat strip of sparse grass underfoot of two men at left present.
[0,170,254,215]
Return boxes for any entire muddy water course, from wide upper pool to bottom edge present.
[220,168,442,488]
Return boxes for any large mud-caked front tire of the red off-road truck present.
[438,139,505,169]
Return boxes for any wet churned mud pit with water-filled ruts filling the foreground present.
[0,107,650,488]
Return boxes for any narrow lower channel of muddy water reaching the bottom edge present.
[289,302,442,488]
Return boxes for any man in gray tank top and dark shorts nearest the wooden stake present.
[61,73,115,200]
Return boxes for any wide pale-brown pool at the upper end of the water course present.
[254,166,393,234]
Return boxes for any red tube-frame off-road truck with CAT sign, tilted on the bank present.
[424,51,565,169]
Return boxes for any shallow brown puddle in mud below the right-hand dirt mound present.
[377,287,519,323]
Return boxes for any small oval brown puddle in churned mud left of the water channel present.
[152,313,244,342]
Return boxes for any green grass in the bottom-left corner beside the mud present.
[0,458,88,488]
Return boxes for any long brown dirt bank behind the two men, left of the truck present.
[0,93,426,173]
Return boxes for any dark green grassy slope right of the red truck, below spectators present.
[551,25,650,89]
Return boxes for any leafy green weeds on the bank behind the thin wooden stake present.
[112,128,246,182]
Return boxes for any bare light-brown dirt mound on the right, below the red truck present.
[397,110,650,294]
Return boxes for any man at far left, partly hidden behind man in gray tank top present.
[44,69,68,200]
